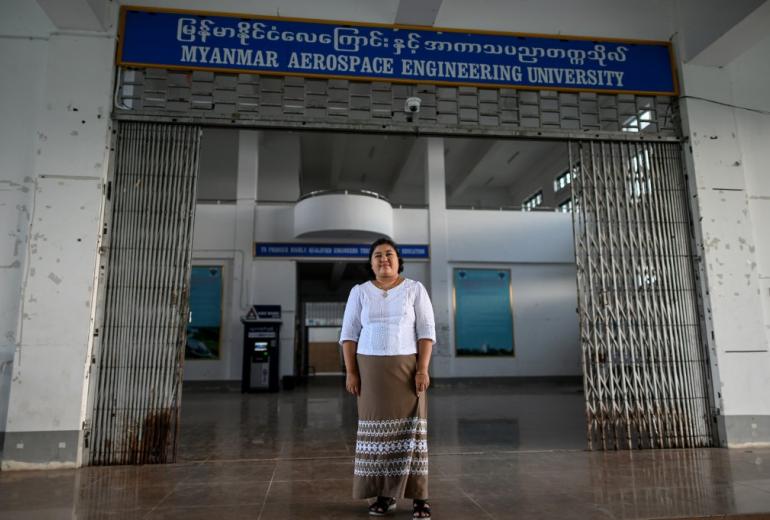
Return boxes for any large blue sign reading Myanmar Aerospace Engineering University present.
[117,7,677,95]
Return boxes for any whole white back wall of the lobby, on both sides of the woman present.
[190,191,580,380]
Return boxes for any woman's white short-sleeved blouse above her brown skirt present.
[340,278,436,356]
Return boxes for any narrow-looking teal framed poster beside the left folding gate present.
[184,265,222,360]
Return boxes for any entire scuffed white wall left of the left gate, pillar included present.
[0,2,114,469]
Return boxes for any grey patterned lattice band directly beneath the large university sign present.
[115,68,678,139]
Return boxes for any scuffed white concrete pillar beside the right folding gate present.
[682,57,770,447]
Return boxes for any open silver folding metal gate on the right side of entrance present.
[570,141,713,450]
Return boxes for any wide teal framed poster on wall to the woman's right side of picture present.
[452,268,514,356]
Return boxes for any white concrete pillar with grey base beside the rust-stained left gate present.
[1,35,113,470]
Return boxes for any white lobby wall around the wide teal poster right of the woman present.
[447,210,581,376]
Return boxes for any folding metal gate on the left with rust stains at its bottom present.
[89,123,201,464]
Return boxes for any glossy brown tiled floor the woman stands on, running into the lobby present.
[0,382,770,520]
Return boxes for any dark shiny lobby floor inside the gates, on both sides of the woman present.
[179,377,586,461]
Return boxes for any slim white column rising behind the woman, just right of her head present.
[423,137,454,377]
